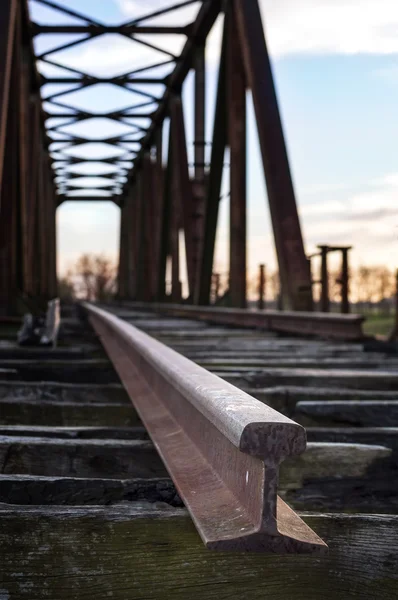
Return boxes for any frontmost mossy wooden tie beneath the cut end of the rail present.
[0,505,398,600]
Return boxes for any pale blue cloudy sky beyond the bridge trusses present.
[31,0,398,282]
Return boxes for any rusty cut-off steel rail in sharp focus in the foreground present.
[84,304,327,553]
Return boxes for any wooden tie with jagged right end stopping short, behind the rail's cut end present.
[0,436,391,488]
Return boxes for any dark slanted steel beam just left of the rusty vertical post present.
[194,26,227,305]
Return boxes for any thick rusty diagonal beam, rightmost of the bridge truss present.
[233,0,312,310]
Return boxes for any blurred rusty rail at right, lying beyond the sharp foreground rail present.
[129,303,365,340]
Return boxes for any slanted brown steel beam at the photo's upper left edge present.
[0,0,17,210]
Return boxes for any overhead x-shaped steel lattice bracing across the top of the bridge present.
[32,0,202,201]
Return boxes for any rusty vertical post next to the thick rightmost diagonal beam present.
[225,10,246,308]
